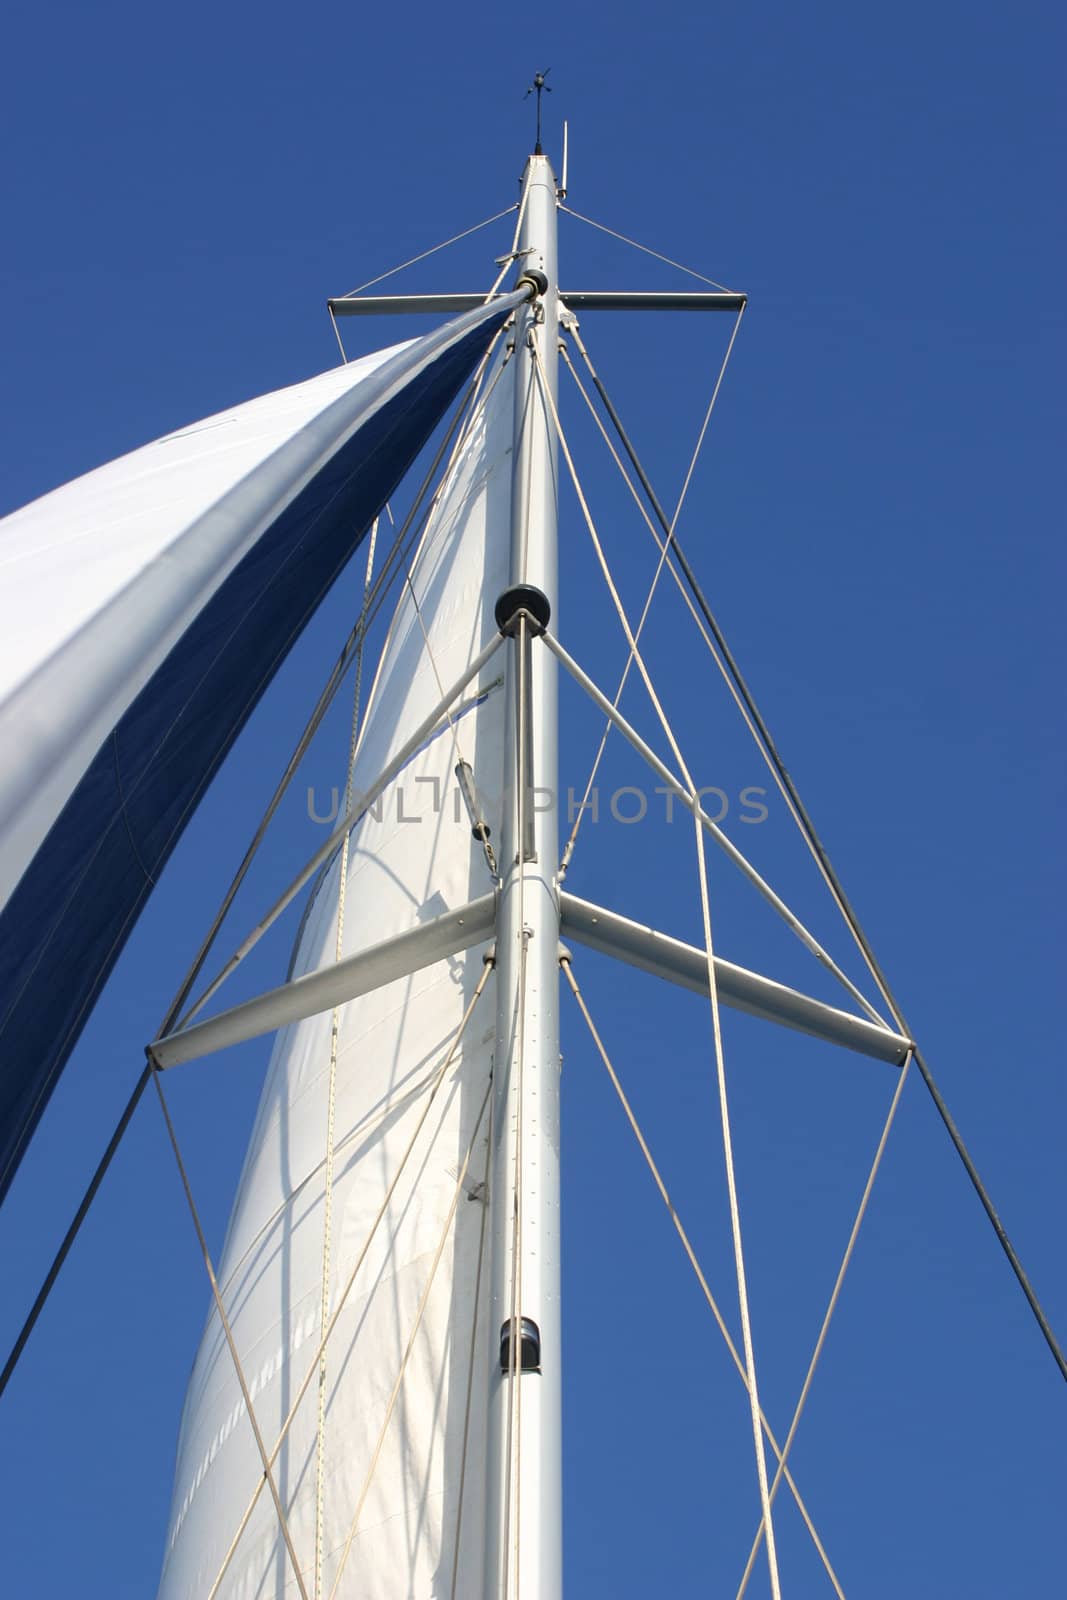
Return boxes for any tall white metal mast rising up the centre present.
[485,149,563,1600]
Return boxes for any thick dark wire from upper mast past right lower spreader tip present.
[559,331,1067,1381]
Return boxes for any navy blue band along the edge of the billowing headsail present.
[0,307,510,1200]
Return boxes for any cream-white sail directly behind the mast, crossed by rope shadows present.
[160,344,514,1600]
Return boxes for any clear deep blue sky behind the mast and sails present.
[0,3,1067,1600]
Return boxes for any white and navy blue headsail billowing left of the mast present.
[0,293,523,1198]
